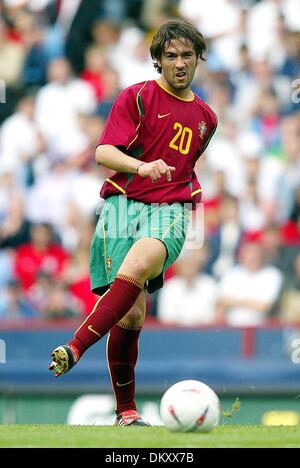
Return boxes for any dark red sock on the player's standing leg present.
[107,325,141,415]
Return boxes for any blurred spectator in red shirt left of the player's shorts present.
[15,224,69,290]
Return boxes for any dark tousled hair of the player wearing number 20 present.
[150,20,206,73]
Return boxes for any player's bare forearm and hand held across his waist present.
[95,145,175,182]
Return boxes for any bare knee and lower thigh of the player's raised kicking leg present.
[118,237,168,284]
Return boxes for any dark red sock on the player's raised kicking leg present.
[69,275,143,357]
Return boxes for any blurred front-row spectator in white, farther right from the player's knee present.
[217,243,283,327]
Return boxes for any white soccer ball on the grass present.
[160,380,221,432]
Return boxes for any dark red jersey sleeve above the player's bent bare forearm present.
[98,88,141,148]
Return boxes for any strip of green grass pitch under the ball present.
[0,425,300,448]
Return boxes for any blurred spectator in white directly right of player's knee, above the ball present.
[158,246,217,326]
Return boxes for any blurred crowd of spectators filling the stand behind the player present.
[0,0,300,326]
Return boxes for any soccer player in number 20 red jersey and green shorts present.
[50,20,217,426]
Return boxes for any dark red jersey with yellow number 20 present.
[99,80,217,205]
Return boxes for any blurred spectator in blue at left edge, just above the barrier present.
[0,280,37,319]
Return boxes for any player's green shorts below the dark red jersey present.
[90,195,189,295]
